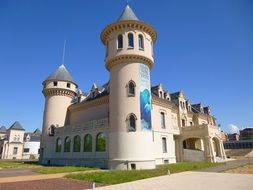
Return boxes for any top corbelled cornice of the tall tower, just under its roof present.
[100,20,157,45]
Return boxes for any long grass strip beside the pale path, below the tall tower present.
[65,162,222,184]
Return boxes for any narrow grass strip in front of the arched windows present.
[34,166,98,174]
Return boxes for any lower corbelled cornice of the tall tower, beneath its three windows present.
[106,54,154,70]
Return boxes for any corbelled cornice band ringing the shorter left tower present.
[42,88,76,98]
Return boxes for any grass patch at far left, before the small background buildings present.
[0,161,41,169]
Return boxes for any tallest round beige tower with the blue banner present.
[101,5,156,169]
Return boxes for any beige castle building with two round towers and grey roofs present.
[40,5,226,169]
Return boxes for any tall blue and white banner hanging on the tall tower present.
[139,64,152,131]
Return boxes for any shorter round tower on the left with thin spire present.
[40,65,77,164]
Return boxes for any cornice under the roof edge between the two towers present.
[69,95,109,111]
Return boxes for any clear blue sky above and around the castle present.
[0,0,253,131]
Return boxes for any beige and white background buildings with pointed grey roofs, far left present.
[0,121,41,159]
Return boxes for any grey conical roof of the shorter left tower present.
[45,65,76,84]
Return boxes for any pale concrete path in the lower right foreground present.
[96,172,253,190]
